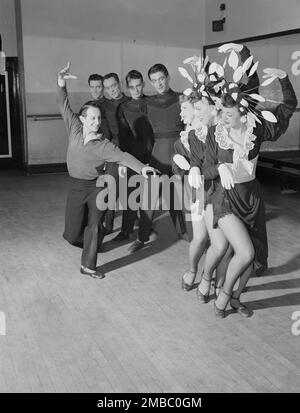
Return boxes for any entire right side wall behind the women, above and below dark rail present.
[205,0,300,151]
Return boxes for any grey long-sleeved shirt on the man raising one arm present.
[57,86,144,180]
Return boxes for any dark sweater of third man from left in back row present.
[118,96,154,163]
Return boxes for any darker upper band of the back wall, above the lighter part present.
[21,0,205,48]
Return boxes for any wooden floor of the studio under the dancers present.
[0,175,300,393]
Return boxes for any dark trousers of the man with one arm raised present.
[63,178,105,270]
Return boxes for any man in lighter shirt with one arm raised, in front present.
[57,64,155,278]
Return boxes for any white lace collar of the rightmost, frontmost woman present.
[215,117,256,163]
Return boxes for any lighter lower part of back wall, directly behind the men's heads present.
[23,36,199,165]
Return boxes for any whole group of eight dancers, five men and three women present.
[58,43,297,318]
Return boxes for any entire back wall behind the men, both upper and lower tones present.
[21,0,205,165]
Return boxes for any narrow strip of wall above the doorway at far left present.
[0,0,18,56]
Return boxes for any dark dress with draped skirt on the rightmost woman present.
[203,77,297,268]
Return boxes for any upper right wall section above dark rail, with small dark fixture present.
[205,0,300,45]
